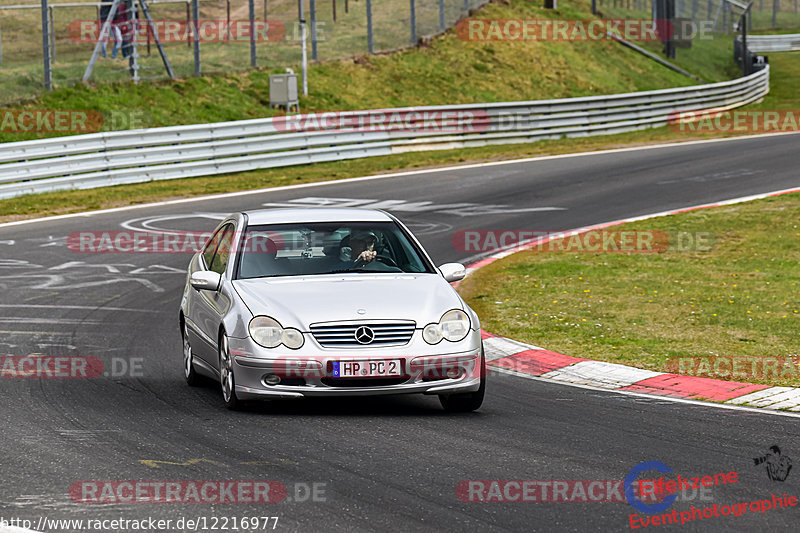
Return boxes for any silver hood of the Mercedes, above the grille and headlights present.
[233,274,464,331]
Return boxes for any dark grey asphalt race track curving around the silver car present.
[0,135,800,531]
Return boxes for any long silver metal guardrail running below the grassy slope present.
[0,68,769,198]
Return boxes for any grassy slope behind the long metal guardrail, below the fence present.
[0,0,716,142]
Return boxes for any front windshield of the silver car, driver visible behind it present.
[237,222,436,279]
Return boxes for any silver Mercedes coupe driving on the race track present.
[180,208,486,412]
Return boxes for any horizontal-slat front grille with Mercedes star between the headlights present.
[311,321,416,348]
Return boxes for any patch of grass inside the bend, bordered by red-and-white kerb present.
[459,194,800,386]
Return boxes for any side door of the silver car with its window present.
[189,222,235,368]
